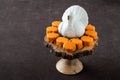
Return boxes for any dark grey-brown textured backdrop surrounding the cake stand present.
[0,0,120,80]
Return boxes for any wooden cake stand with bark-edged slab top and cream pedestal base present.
[44,37,98,75]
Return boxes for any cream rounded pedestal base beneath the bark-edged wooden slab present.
[56,59,83,75]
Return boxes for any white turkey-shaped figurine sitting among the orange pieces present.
[58,5,88,38]
